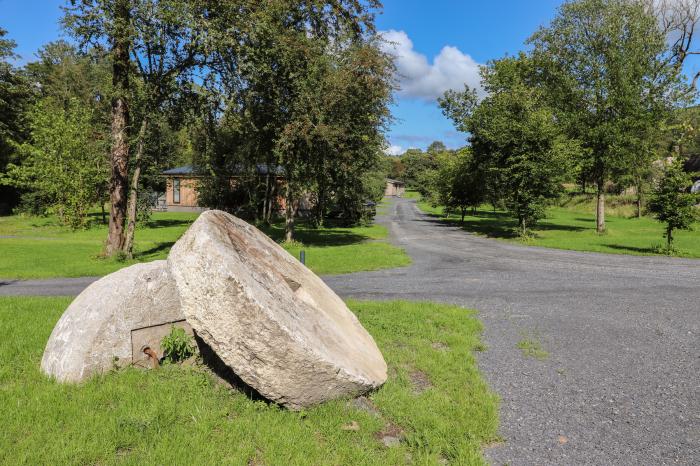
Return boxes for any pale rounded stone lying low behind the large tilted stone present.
[41,261,184,382]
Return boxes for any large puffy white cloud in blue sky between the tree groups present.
[381,29,483,101]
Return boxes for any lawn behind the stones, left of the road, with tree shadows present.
[0,212,410,278]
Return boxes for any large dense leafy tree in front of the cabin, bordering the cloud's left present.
[197,0,391,240]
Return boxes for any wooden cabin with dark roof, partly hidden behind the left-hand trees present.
[162,163,285,212]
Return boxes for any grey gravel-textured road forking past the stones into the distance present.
[0,199,700,465]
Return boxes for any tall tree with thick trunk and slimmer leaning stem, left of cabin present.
[63,0,205,256]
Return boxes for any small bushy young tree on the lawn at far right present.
[649,157,698,254]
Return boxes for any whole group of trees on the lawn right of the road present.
[402,0,698,251]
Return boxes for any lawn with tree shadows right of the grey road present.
[418,194,700,258]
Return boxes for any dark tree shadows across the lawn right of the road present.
[427,211,586,239]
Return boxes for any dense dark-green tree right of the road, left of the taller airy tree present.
[440,54,575,235]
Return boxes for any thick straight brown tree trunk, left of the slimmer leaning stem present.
[105,0,130,256]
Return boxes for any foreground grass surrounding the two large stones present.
[0,298,498,465]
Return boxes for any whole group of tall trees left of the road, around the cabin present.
[0,0,393,255]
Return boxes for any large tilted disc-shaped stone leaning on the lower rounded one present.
[168,211,387,409]
